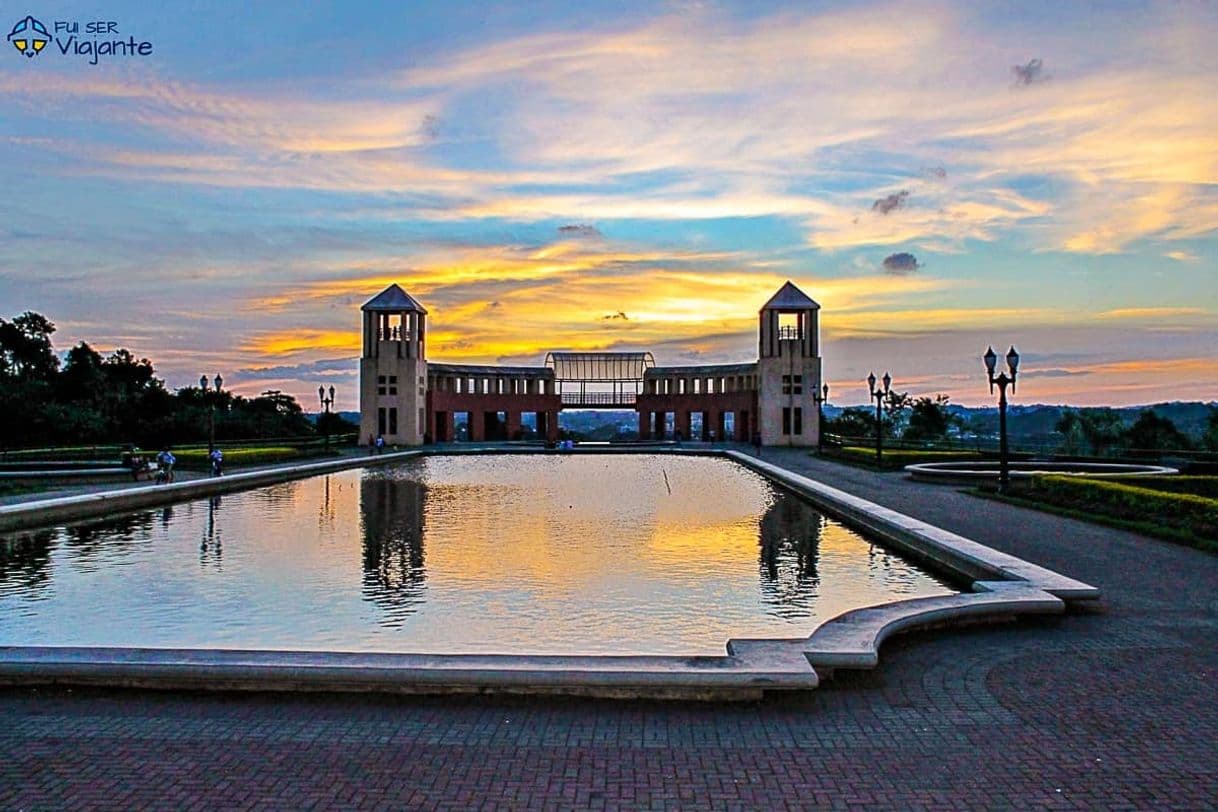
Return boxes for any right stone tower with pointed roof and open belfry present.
[758,282,821,446]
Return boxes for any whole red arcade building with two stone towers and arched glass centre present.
[359,281,821,446]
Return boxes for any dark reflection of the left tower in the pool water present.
[359,476,428,627]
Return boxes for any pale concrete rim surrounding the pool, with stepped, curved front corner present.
[0,447,1100,699]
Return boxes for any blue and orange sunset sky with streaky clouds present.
[0,0,1218,409]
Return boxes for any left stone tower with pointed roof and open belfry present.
[359,285,428,446]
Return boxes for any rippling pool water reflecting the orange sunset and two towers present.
[0,454,952,654]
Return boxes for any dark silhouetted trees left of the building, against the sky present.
[0,313,345,448]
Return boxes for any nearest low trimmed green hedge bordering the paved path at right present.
[1024,474,1218,551]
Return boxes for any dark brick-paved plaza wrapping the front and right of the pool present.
[0,450,1218,810]
